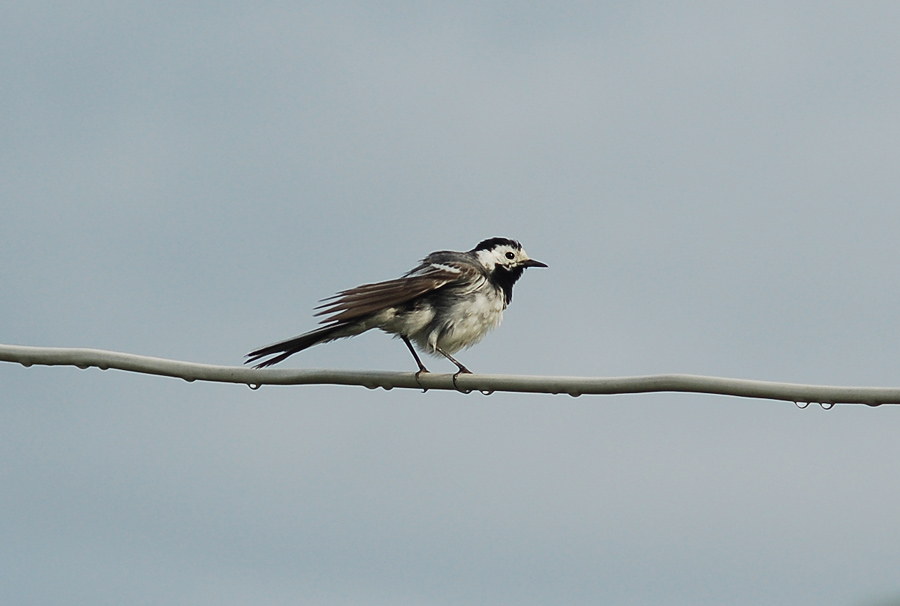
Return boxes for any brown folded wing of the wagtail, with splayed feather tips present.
[315,264,475,324]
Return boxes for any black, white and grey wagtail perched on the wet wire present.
[245,238,547,375]
